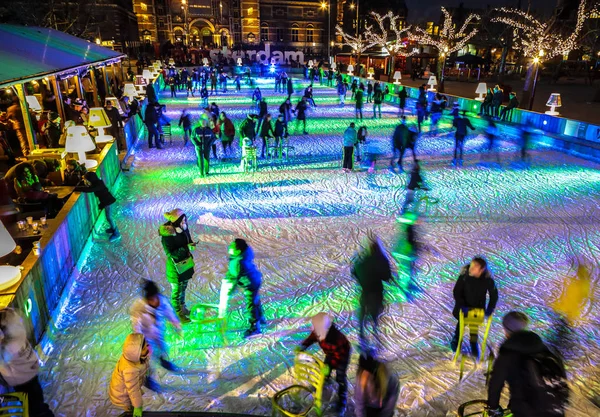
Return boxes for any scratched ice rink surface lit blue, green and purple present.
[41,79,600,417]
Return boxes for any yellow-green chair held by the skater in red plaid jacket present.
[271,352,329,417]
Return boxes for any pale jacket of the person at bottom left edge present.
[0,308,40,387]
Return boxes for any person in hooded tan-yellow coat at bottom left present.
[108,333,150,417]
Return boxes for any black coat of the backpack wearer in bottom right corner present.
[488,330,547,417]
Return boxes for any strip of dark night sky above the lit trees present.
[400,0,557,21]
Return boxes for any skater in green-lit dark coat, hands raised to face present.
[158,209,196,323]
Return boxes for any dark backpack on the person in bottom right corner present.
[527,350,569,417]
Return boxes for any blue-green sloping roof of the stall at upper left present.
[0,25,125,87]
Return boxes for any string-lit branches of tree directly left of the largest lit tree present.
[409,7,481,55]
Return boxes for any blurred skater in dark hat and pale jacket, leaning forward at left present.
[129,280,181,370]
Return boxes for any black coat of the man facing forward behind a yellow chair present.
[452,265,498,318]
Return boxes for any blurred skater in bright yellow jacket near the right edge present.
[549,262,591,359]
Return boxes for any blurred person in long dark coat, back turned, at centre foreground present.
[352,235,392,347]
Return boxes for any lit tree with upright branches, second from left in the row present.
[365,11,412,73]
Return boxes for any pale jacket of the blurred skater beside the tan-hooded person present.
[129,295,180,341]
